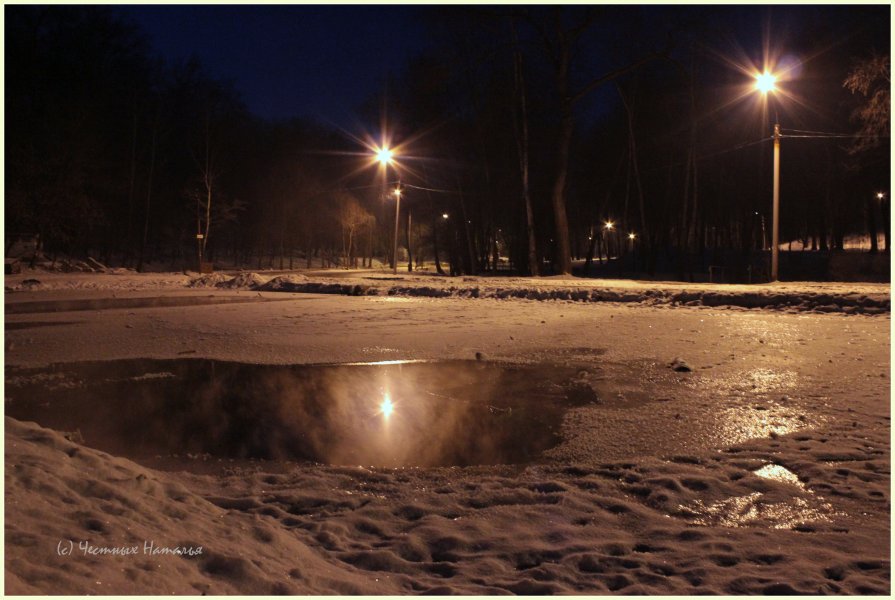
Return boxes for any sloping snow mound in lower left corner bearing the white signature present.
[5,418,390,595]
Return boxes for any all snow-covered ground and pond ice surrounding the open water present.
[5,272,891,594]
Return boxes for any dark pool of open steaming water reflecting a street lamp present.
[6,359,597,467]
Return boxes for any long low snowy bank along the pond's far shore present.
[6,271,891,315]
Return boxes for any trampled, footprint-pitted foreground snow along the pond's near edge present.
[6,419,889,595]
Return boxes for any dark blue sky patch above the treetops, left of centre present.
[117,5,426,123]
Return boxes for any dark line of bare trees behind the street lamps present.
[5,6,890,278]
